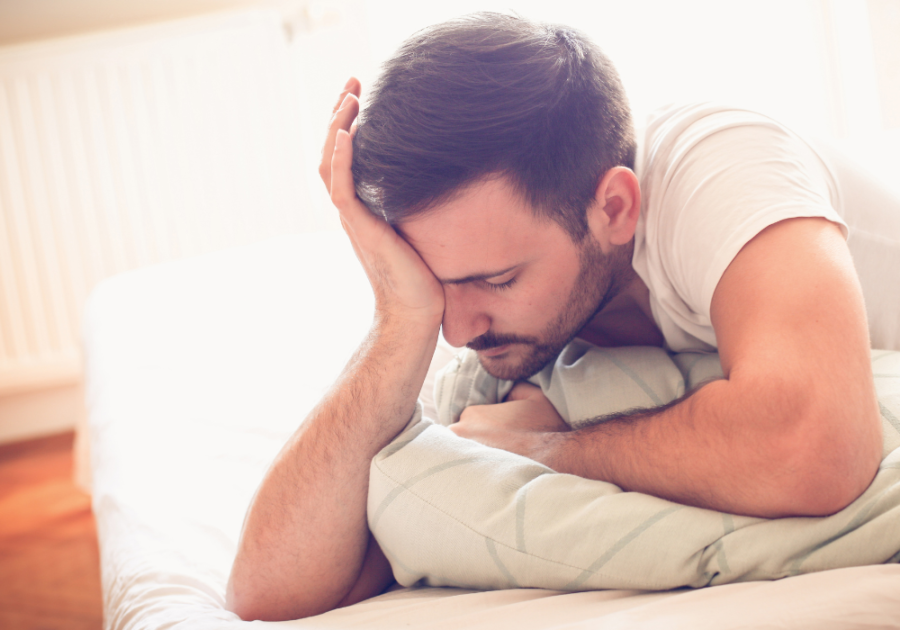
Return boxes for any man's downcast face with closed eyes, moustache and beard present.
[398,178,630,380]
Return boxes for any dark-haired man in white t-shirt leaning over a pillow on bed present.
[228,14,881,619]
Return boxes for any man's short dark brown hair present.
[353,13,635,242]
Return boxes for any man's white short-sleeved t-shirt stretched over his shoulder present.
[633,103,847,352]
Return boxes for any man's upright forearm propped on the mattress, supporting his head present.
[228,324,438,619]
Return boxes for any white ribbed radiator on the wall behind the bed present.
[0,11,329,396]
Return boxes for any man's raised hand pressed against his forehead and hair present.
[319,79,444,332]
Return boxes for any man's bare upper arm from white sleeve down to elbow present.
[711,218,881,513]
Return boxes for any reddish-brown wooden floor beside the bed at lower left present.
[0,433,102,630]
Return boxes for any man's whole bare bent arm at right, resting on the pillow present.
[455,219,881,517]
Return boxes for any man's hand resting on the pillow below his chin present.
[450,383,570,470]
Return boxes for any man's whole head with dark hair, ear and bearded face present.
[353,14,640,379]
